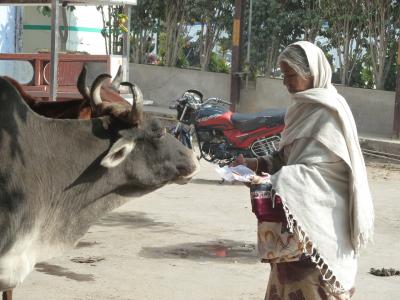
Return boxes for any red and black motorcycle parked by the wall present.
[170,90,286,166]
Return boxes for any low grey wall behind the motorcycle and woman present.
[130,64,395,137]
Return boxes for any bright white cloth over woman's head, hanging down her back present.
[293,41,374,253]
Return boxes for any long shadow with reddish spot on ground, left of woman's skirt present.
[139,240,259,264]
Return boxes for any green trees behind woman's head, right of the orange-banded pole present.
[242,0,400,89]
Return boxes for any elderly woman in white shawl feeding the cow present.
[236,41,374,300]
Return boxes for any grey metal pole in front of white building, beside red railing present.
[49,0,59,101]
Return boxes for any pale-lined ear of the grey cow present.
[100,137,136,168]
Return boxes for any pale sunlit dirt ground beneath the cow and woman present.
[14,158,400,300]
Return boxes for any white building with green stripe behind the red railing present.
[0,1,134,83]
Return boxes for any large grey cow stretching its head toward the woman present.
[0,77,198,291]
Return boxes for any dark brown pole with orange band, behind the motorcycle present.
[230,0,246,111]
